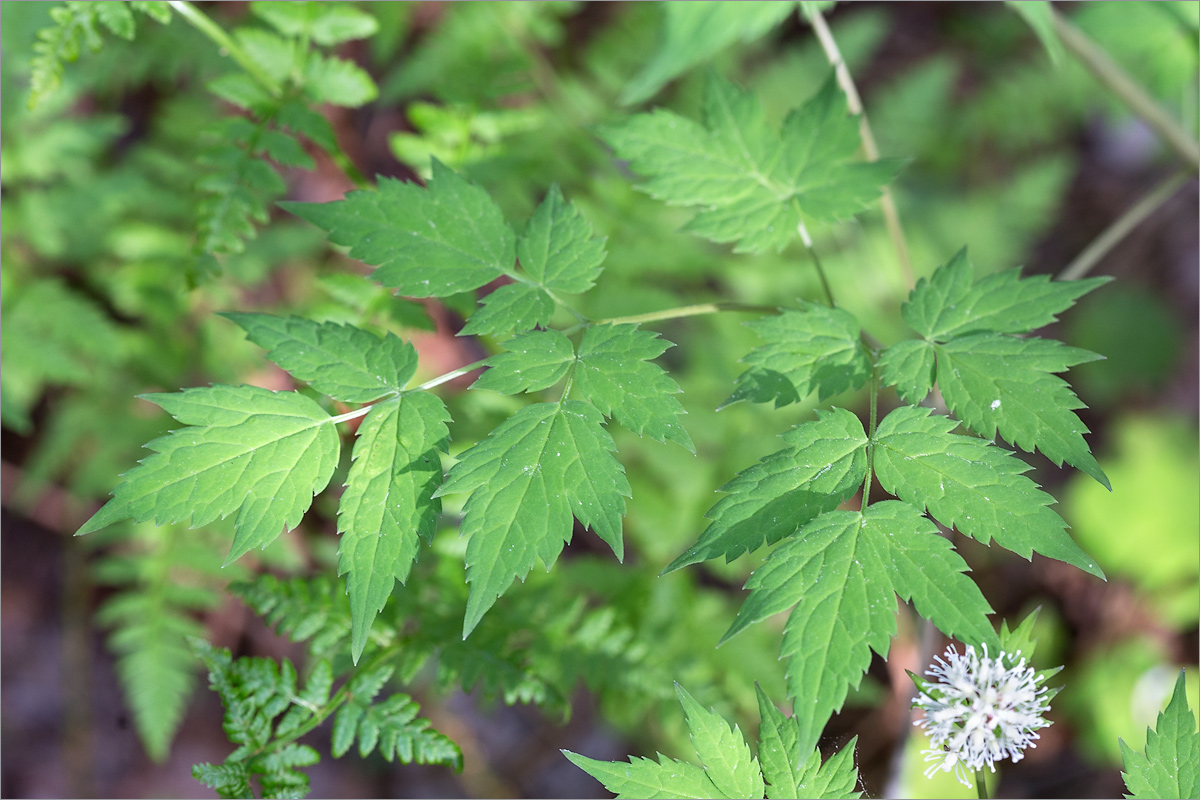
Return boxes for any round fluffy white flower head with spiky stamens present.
[913,645,1050,787]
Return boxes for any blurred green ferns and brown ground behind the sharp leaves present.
[0,2,1200,796]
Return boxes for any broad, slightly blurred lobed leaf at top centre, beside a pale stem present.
[601,76,900,253]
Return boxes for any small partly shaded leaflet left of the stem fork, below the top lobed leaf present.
[721,301,871,408]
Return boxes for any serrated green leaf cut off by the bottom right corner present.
[1121,670,1200,800]
